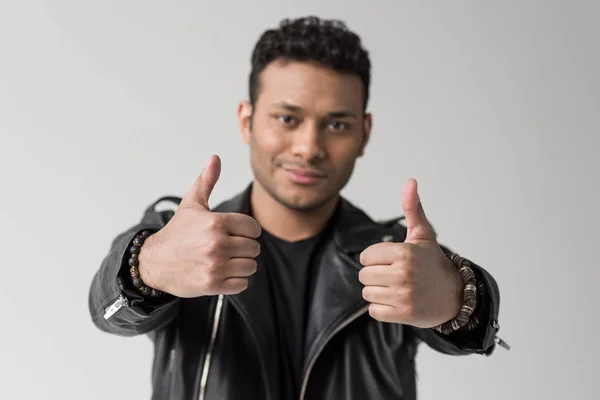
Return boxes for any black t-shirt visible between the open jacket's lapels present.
[259,229,325,394]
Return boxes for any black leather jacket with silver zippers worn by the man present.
[89,189,500,400]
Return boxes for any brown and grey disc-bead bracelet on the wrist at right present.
[434,253,479,334]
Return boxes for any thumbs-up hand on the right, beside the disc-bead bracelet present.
[359,179,463,328]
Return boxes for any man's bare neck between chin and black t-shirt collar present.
[250,181,339,242]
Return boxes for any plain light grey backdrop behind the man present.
[0,0,600,399]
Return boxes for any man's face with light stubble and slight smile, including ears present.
[238,62,371,210]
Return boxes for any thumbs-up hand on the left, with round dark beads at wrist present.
[139,156,261,298]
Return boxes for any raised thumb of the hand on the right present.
[402,179,436,242]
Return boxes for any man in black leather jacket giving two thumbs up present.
[90,17,506,400]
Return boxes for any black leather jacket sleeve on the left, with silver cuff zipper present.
[88,198,180,336]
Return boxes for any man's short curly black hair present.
[249,16,371,111]
